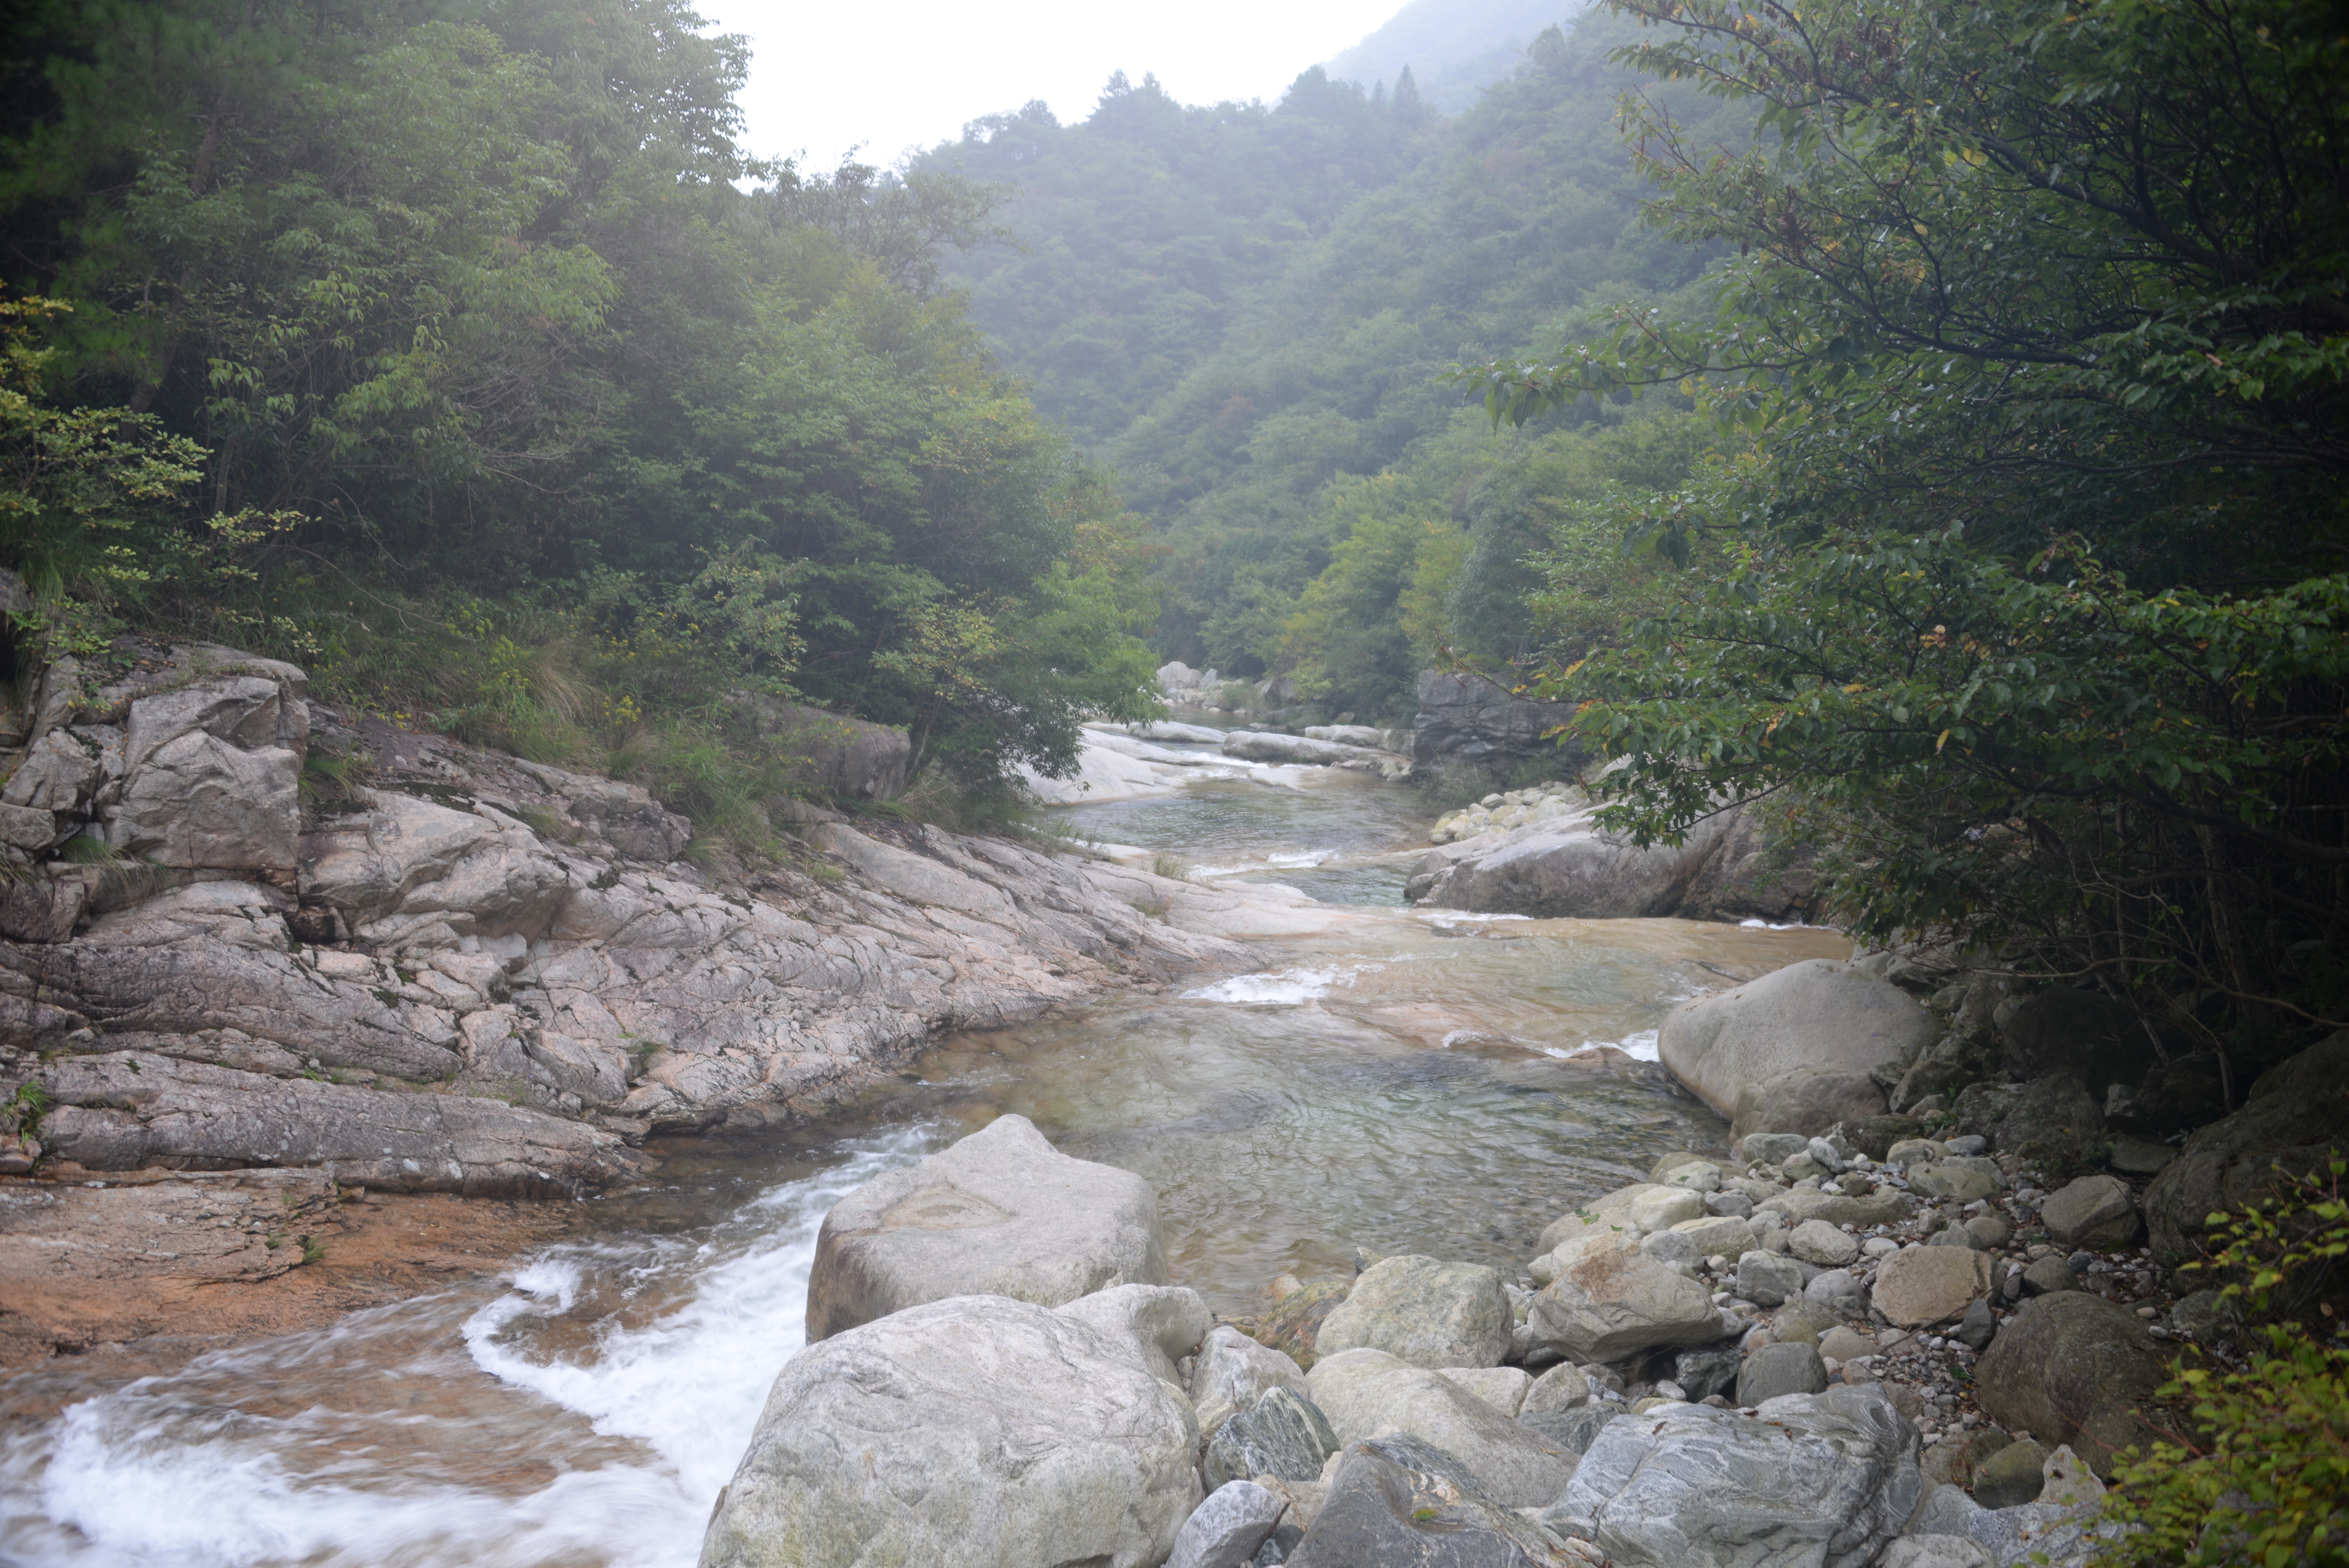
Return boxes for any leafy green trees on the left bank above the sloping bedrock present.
[0,0,1151,821]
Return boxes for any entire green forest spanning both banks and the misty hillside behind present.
[0,0,2349,1040]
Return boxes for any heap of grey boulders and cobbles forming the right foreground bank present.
[702,960,2349,1568]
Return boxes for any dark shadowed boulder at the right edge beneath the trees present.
[2145,1030,2349,1263]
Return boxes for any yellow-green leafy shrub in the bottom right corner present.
[2093,1160,2349,1568]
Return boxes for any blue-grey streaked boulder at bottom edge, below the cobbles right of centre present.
[1541,1383,1924,1568]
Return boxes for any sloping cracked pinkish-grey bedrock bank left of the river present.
[0,645,1332,1345]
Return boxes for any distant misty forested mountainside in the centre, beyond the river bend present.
[923,16,1745,718]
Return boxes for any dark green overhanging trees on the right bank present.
[1459,0,2349,1028]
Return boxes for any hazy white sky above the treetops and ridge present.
[700,0,1403,169]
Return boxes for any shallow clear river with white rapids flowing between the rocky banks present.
[0,751,1851,1568]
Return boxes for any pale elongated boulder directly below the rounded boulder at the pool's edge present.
[1306,1350,1574,1507]
